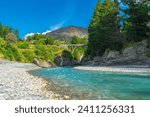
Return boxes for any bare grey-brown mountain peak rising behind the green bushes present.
[46,26,88,41]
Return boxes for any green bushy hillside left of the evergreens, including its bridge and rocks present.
[0,24,87,67]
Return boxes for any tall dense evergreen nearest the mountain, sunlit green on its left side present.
[88,0,121,56]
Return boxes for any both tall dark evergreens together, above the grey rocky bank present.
[88,0,150,56]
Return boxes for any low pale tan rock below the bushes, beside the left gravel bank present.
[33,58,56,68]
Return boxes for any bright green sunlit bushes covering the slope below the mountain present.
[0,24,87,63]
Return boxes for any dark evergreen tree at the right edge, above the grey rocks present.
[122,0,150,41]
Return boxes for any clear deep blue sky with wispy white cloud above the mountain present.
[0,0,97,37]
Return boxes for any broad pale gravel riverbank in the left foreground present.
[0,60,57,100]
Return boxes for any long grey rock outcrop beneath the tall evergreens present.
[82,40,150,66]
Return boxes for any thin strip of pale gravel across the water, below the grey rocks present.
[74,66,150,74]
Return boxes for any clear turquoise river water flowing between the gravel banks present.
[32,67,150,100]
